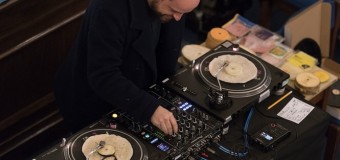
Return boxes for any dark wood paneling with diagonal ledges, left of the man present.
[0,0,89,159]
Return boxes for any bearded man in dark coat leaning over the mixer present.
[55,0,199,134]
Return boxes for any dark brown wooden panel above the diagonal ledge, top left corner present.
[0,0,89,57]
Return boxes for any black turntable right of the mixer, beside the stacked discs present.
[161,41,289,122]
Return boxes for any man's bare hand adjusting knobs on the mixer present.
[151,106,178,135]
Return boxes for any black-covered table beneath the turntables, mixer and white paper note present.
[31,90,330,160]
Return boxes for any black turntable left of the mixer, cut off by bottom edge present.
[33,125,150,160]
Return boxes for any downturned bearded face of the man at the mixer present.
[149,0,199,23]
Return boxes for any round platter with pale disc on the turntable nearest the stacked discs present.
[195,51,271,98]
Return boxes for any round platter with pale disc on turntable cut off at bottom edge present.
[64,129,148,160]
